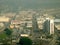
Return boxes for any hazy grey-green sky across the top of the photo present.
[0,0,60,8]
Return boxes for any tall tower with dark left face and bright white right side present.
[44,18,54,34]
